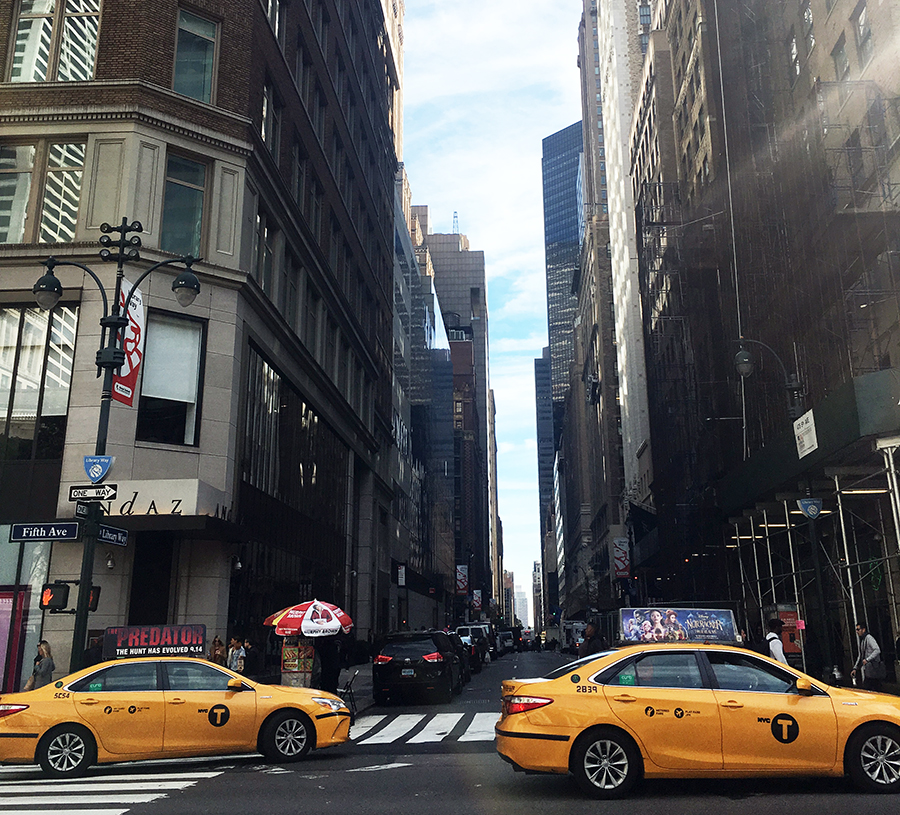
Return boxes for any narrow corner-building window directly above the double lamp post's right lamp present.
[159,154,206,257]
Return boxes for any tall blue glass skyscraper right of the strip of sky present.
[541,122,583,424]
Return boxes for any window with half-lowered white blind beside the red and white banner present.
[136,312,204,445]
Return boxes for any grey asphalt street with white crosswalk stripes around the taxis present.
[0,652,896,815]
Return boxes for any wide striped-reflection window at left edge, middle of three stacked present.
[0,142,85,243]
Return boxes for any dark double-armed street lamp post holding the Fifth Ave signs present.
[32,218,200,671]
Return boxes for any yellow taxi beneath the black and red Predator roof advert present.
[0,657,350,778]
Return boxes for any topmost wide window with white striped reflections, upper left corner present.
[9,0,100,82]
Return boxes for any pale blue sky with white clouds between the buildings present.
[403,0,582,628]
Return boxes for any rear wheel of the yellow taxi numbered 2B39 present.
[570,728,641,798]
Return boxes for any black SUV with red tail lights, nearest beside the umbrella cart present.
[372,630,462,705]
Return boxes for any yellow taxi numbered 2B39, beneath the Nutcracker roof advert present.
[495,643,900,798]
